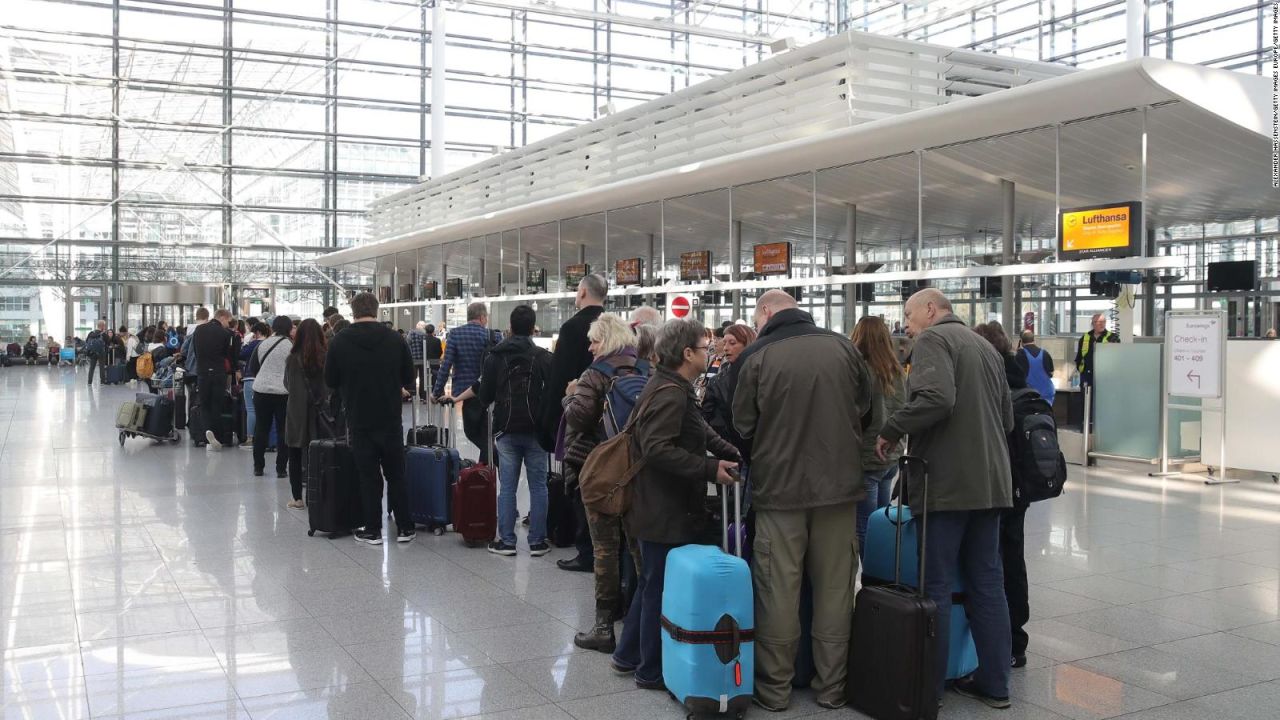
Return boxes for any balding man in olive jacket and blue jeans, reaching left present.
[876,288,1014,708]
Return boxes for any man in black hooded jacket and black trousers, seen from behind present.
[324,292,415,544]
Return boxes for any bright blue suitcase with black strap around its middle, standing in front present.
[660,486,755,717]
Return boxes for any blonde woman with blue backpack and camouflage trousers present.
[563,313,649,652]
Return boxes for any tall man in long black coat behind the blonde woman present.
[539,274,609,573]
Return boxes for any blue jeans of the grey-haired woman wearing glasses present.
[613,541,678,683]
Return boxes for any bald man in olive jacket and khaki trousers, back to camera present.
[730,290,872,711]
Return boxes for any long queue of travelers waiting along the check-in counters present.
[0,274,1080,711]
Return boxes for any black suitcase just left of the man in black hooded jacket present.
[305,439,365,536]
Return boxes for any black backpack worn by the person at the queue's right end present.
[1009,388,1066,506]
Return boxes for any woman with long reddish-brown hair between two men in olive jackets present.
[850,315,906,552]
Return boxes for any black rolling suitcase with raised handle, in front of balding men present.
[846,455,938,720]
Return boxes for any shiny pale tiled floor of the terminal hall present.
[0,368,1280,720]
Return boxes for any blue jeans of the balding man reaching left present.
[924,510,1012,697]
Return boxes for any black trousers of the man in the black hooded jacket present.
[351,425,413,534]
